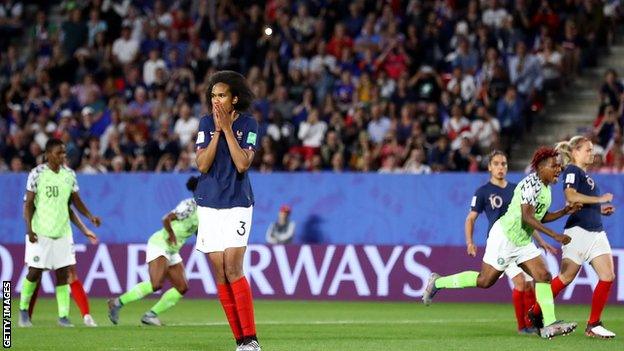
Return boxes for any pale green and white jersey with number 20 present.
[26,164,78,239]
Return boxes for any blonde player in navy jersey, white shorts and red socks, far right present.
[531,136,615,338]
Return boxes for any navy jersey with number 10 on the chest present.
[470,182,516,233]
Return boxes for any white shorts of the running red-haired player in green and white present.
[483,222,542,275]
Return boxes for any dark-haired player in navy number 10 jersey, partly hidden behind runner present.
[464,150,557,334]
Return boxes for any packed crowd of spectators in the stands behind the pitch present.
[0,0,624,174]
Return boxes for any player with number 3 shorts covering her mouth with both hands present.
[195,71,260,351]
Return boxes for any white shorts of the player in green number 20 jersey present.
[24,235,76,270]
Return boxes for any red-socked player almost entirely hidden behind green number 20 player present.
[27,207,98,327]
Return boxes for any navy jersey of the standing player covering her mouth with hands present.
[195,113,258,208]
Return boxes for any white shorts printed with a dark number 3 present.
[195,206,253,253]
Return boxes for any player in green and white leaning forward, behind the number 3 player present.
[108,177,198,326]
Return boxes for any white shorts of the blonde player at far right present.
[561,227,611,266]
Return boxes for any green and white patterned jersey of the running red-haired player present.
[498,173,552,246]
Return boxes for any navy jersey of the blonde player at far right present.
[562,164,603,232]
